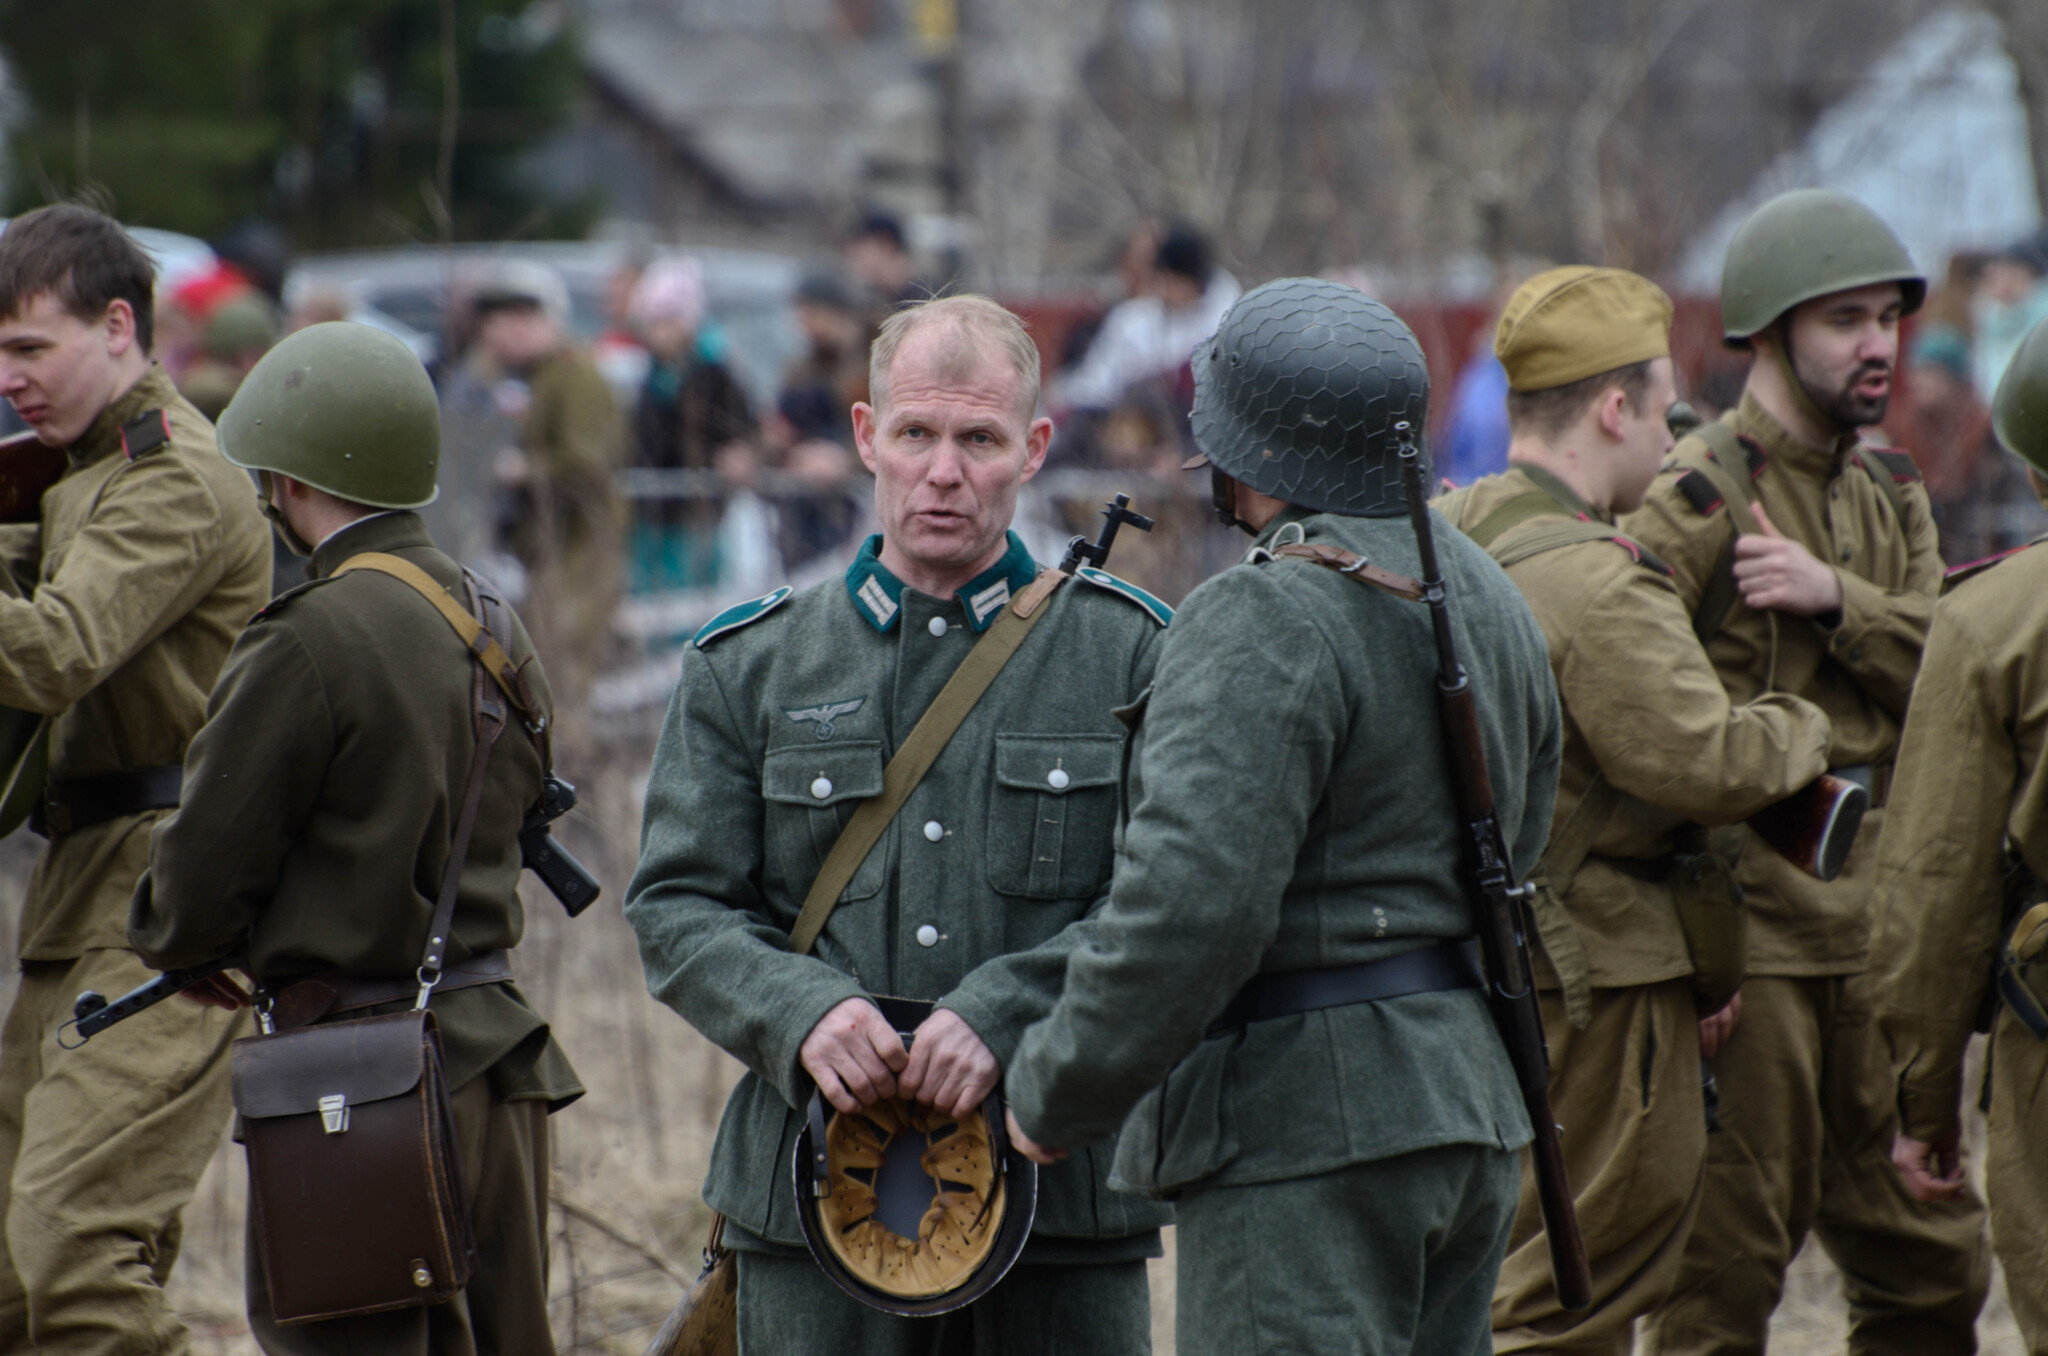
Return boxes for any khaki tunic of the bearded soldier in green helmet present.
[1622,393,1942,975]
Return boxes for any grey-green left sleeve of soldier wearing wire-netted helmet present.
[1008,569,1335,1147]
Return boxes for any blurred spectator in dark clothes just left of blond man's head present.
[768,270,868,569]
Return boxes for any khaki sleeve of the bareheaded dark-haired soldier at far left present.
[0,455,236,715]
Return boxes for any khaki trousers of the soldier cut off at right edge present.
[1985,1006,2048,1356]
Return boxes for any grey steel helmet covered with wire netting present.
[1194,279,1430,518]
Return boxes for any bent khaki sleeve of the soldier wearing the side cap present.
[1556,561,1829,825]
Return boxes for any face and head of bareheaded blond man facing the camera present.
[854,326,1053,596]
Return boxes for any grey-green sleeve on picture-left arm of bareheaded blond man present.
[625,647,864,1106]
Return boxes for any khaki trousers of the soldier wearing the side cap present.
[1493,977,1706,1356]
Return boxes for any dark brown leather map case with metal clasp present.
[233,1008,477,1323]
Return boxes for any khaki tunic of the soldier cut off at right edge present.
[1870,545,2048,1141]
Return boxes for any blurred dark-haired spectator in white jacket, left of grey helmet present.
[1053,225,1239,410]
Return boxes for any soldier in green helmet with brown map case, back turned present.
[129,322,582,1356]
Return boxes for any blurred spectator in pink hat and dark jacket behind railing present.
[629,258,756,592]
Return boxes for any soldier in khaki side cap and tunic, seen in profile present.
[1438,268,1829,1354]
